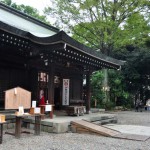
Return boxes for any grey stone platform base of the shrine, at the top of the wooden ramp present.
[24,113,117,133]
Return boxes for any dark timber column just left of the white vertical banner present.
[48,64,54,118]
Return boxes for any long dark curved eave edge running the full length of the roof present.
[0,21,124,67]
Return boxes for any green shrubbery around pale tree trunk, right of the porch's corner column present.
[91,70,131,108]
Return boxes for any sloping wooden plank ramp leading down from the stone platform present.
[71,120,120,136]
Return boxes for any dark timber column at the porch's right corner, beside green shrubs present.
[86,72,91,114]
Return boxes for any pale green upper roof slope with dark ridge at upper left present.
[0,3,59,37]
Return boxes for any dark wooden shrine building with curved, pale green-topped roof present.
[0,3,123,113]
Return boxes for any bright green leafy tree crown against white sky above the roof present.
[45,0,150,55]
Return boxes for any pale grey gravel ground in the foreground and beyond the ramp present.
[0,111,150,150]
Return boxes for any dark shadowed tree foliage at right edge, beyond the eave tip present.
[123,48,150,102]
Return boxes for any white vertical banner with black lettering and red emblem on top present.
[62,79,69,106]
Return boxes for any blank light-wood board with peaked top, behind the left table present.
[5,87,31,109]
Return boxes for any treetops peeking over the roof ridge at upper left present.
[0,0,50,24]
